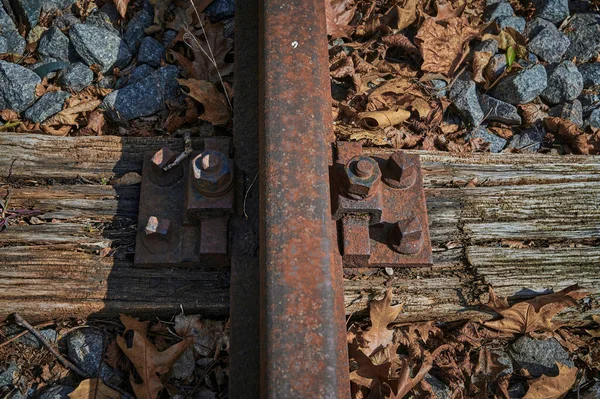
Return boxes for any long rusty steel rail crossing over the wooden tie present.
[259,0,350,398]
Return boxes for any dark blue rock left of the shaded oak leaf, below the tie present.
[65,328,105,378]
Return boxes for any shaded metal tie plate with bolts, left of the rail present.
[134,137,235,267]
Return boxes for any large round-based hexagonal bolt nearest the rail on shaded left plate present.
[192,150,233,196]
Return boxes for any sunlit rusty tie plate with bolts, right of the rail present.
[330,142,432,267]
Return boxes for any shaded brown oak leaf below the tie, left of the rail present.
[117,315,193,399]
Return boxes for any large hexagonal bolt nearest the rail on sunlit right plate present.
[341,155,381,200]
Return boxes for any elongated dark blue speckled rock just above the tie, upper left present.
[102,65,179,121]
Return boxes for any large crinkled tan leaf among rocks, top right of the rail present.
[415,9,479,76]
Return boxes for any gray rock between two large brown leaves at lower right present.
[508,336,575,378]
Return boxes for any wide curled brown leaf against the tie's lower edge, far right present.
[483,284,587,334]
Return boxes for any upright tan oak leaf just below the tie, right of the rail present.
[359,288,402,356]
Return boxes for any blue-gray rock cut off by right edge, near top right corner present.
[564,14,600,62]
